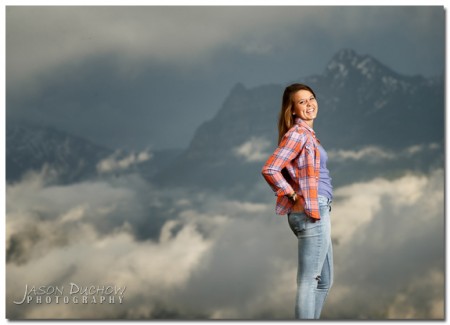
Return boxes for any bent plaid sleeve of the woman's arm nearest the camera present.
[261,128,305,196]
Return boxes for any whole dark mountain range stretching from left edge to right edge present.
[6,49,444,190]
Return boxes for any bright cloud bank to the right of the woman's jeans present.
[329,170,444,319]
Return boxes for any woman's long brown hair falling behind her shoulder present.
[278,83,316,144]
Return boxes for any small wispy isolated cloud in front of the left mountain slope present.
[97,150,153,173]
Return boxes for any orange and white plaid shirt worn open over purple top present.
[262,118,320,219]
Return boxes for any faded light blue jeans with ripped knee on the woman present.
[288,195,333,319]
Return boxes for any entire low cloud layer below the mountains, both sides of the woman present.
[6,166,444,319]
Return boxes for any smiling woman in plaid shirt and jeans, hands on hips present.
[262,84,333,319]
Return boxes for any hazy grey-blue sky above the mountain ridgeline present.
[6,6,445,149]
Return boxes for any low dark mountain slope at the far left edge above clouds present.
[6,121,185,183]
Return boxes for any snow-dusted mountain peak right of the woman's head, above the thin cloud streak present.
[305,50,444,149]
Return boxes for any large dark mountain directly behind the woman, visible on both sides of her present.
[155,49,444,193]
